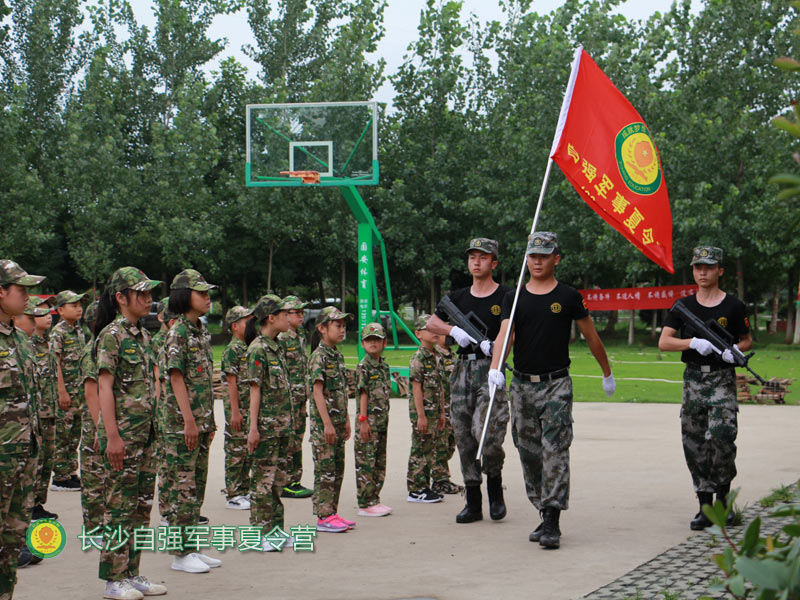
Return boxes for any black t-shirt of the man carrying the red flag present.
[502,283,589,375]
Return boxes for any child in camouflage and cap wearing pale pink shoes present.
[354,323,392,517]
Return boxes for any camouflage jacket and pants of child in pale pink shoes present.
[353,354,392,508]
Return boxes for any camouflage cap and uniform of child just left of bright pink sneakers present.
[247,294,294,535]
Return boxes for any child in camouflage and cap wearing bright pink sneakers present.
[309,306,355,533]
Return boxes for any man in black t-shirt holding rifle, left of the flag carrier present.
[428,238,510,523]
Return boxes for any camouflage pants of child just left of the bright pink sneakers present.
[250,436,292,535]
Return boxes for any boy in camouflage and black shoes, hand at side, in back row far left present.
[50,290,86,492]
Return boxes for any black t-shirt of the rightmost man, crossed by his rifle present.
[664,294,750,366]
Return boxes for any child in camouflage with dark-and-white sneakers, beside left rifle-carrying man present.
[406,315,445,503]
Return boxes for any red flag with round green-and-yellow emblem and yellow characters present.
[551,48,675,273]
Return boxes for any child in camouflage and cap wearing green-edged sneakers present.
[278,296,313,498]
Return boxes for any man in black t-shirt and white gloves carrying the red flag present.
[489,231,616,548]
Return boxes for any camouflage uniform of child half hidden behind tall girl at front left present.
[80,342,105,531]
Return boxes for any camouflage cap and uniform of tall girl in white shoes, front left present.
[96,308,160,581]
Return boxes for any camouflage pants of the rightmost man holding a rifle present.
[681,368,739,492]
